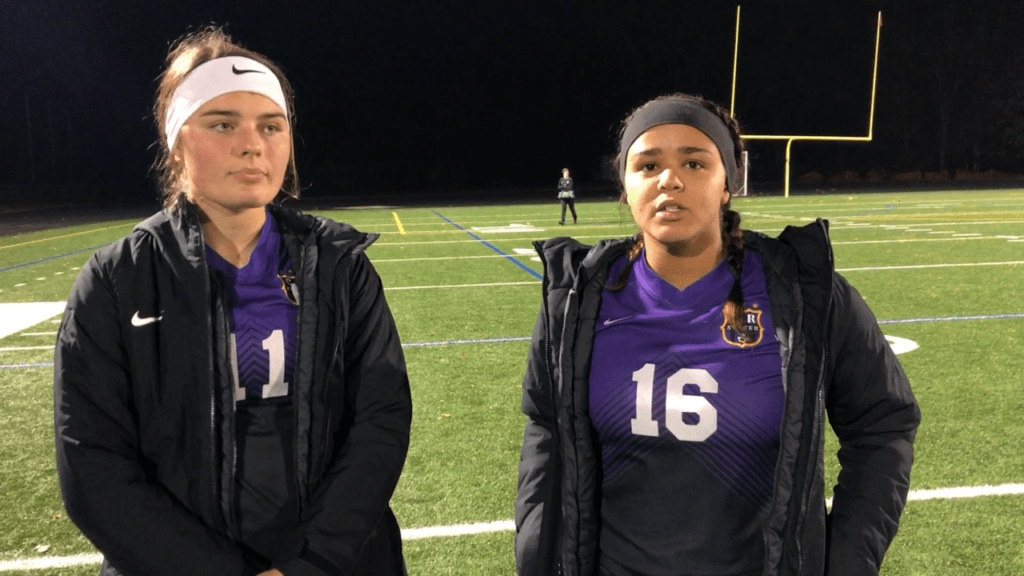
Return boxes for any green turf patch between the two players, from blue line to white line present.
[394,342,528,528]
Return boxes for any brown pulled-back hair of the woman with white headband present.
[153,26,299,210]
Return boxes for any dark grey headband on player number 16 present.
[618,98,738,192]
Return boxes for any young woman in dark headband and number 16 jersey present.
[515,94,920,576]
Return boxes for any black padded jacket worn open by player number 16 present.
[515,220,921,576]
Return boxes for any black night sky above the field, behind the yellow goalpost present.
[0,0,1024,204]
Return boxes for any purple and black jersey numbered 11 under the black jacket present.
[206,213,298,559]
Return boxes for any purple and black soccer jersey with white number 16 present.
[590,250,784,575]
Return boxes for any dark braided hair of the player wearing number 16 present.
[606,93,750,336]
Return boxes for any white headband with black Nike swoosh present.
[164,56,288,150]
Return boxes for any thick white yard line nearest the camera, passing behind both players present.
[0,484,1024,572]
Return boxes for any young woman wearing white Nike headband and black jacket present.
[54,29,412,576]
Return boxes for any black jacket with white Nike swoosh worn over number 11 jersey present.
[54,205,412,576]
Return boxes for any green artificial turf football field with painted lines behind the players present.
[0,190,1024,576]
